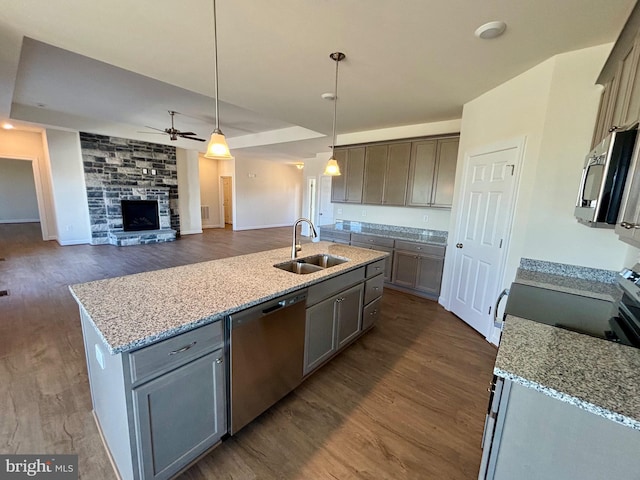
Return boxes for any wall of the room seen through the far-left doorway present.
[0,158,40,223]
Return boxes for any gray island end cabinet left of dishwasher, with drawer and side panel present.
[80,308,227,480]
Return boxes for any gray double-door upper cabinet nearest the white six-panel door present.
[406,137,460,207]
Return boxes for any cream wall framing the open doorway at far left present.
[0,129,57,240]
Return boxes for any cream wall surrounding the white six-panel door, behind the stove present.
[441,45,632,312]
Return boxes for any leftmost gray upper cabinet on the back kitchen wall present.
[331,147,365,203]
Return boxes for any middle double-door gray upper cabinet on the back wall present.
[362,142,411,205]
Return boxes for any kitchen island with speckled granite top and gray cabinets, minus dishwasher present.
[70,242,386,480]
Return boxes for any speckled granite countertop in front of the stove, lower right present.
[494,315,640,430]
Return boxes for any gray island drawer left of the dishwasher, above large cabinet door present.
[129,321,224,383]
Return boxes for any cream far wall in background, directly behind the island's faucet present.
[233,159,303,230]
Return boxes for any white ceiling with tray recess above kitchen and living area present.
[0,0,635,161]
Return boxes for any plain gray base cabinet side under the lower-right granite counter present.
[478,380,640,480]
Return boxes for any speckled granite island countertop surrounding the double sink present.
[69,242,388,354]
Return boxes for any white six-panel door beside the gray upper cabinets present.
[450,142,522,338]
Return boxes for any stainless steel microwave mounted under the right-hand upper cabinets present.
[575,124,638,228]
